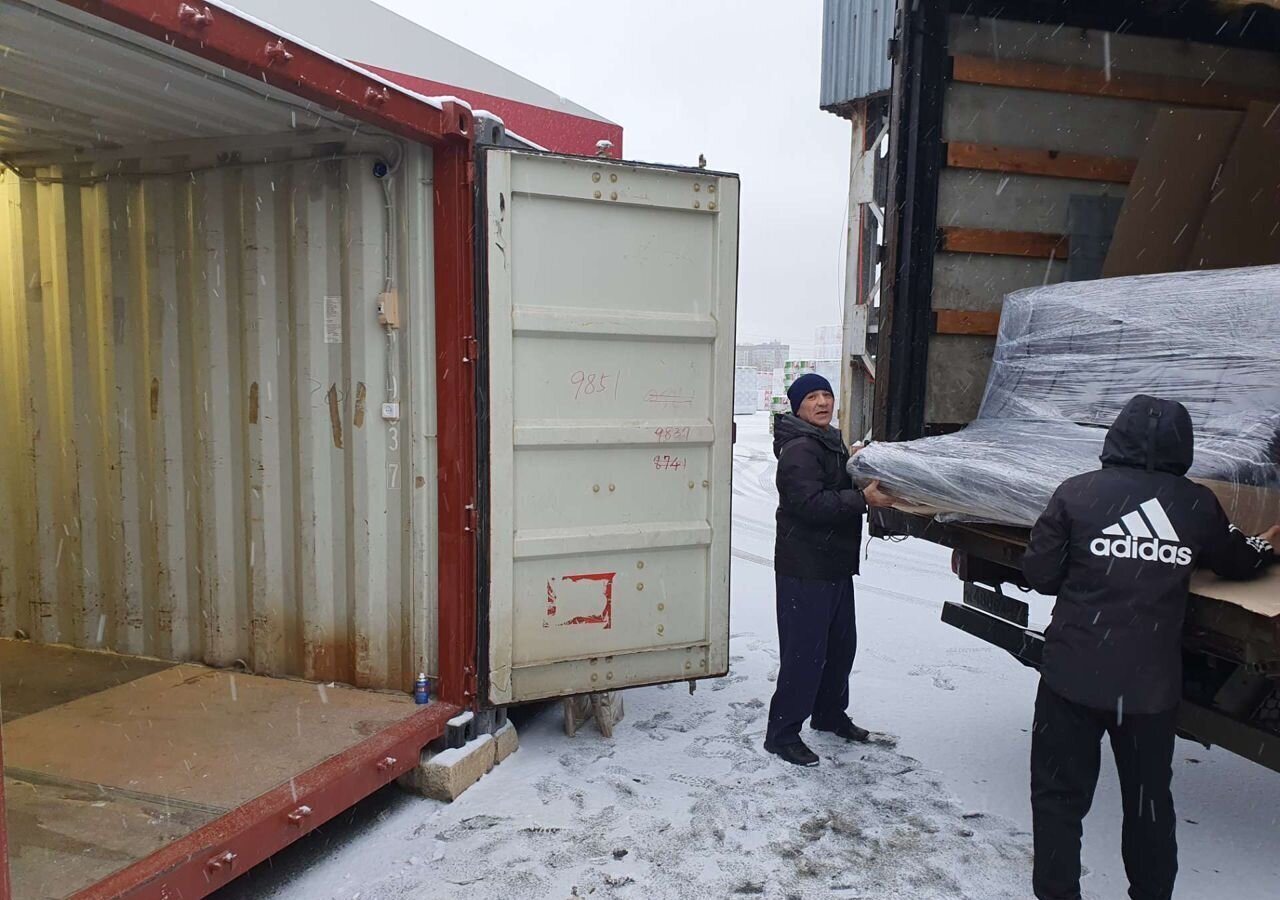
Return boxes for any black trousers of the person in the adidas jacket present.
[1032,681,1178,900]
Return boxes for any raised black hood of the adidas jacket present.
[1102,394,1196,475]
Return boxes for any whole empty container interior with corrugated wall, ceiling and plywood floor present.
[0,0,436,897]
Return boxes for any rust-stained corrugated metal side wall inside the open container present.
[0,143,436,687]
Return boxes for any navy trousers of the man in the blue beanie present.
[764,575,858,746]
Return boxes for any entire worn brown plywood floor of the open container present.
[0,640,415,900]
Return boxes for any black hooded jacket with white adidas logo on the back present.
[1023,394,1275,716]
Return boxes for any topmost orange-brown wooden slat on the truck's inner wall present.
[951,55,1280,110]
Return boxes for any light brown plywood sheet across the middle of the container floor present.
[4,664,417,808]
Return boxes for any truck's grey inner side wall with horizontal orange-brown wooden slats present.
[925,15,1280,424]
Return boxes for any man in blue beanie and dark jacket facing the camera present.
[764,373,893,766]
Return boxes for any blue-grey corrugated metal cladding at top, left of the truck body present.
[818,0,897,111]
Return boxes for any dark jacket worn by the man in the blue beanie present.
[773,415,867,581]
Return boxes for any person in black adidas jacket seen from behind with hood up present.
[1023,396,1280,900]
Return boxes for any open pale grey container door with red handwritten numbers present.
[477,150,739,704]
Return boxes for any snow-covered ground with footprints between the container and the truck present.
[219,414,1280,900]
